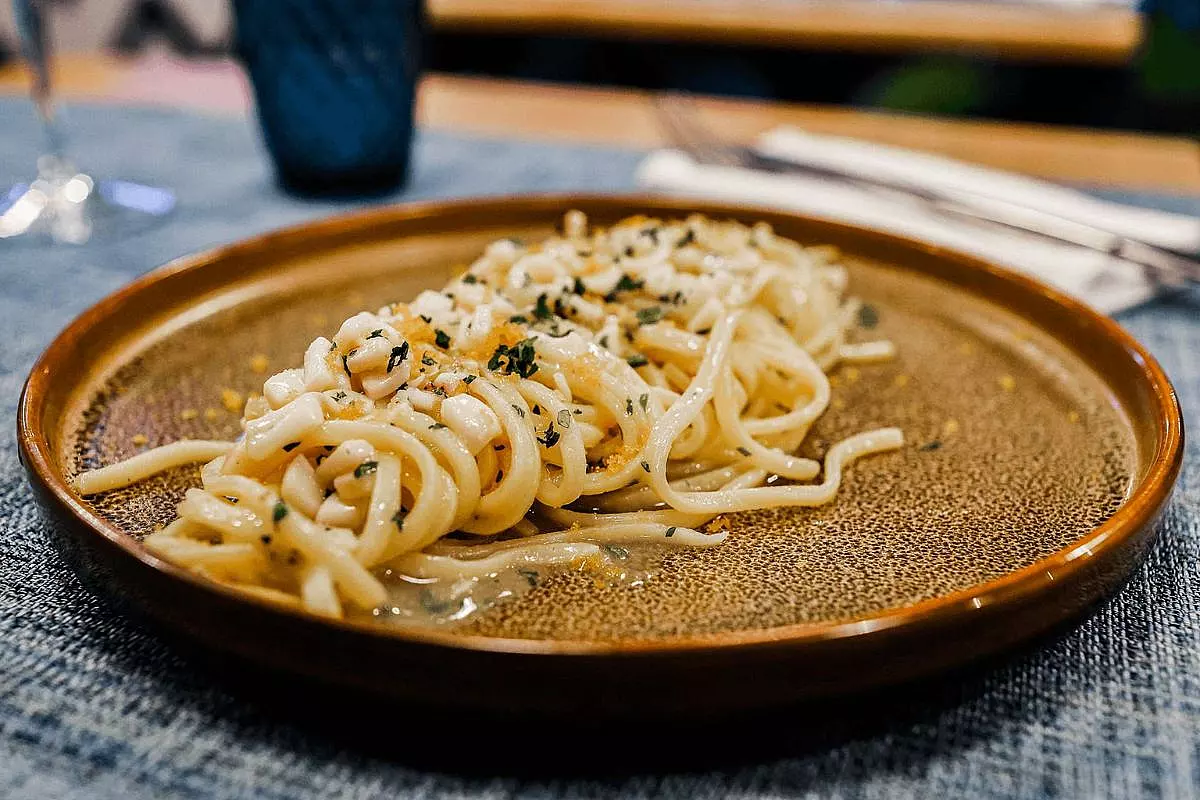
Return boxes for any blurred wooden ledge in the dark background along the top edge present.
[428,0,1142,62]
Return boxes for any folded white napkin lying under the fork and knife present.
[637,128,1200,314]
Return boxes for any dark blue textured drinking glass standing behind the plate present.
[234,0,425,196]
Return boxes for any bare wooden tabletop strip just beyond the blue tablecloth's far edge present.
[0,54,1200,194]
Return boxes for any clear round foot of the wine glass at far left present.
[0,169,175,246]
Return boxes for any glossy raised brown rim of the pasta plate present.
[17,192,1184,657]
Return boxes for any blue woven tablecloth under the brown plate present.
[0,102,1200,800]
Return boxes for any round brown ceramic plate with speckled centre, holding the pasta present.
[18,197,1183,714]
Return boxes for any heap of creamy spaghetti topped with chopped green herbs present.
[76,211,902,620]
